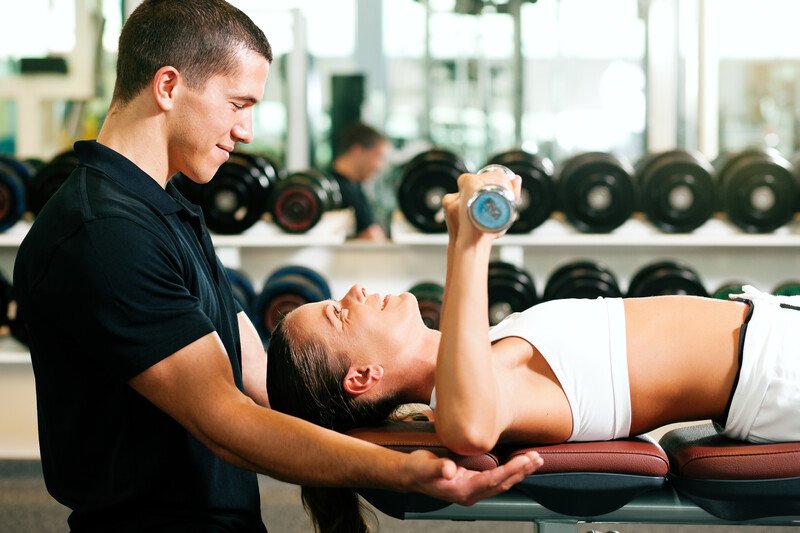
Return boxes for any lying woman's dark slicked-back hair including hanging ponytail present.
[267,313,400,533]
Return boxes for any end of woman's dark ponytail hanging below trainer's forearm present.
[301,487,375,533]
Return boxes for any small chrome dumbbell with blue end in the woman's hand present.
[467,165,517,233]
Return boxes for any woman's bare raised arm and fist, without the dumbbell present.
[436,171,520,455]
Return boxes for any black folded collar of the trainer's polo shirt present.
[74,141,188,215]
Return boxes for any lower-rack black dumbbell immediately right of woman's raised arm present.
[487,261,539,326]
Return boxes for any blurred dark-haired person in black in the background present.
[330,122,390,242]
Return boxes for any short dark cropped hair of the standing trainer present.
[113,0,272,104]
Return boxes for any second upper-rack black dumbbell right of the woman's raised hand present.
[558,152,637,233]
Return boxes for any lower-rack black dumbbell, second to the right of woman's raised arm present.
[543,261,622,300]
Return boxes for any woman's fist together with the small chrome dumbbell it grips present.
[442,165,522,239]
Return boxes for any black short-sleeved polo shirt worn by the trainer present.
[14,142,265,532]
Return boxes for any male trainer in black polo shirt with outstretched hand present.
[14,0,541,533]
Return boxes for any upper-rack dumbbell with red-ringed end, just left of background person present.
[269,168,342,233]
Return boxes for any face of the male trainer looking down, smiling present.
[168,50,269,183]
